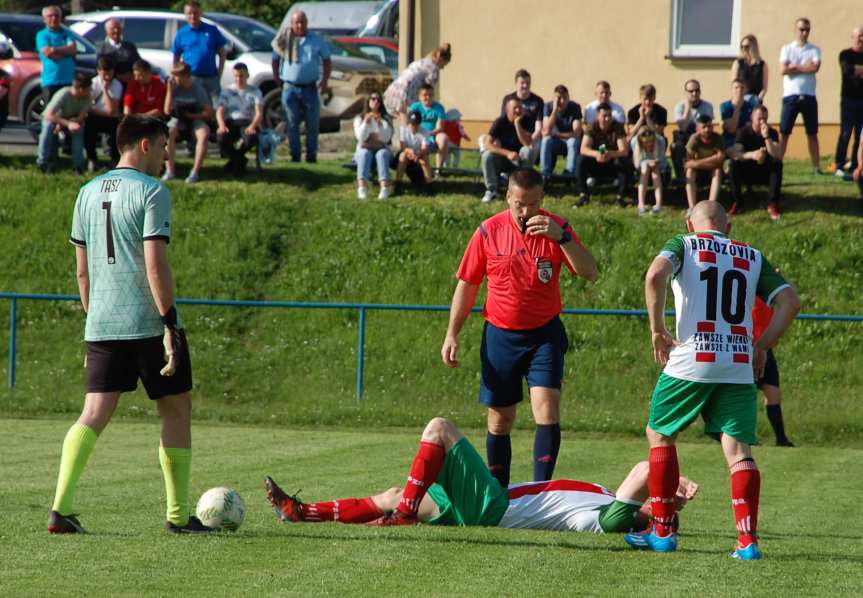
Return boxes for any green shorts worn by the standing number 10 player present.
[648,373,758,444]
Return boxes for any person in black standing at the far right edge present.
[831,25,863,177]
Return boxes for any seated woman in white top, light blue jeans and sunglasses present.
[354,92,393,199]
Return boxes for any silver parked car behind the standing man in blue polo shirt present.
[66,10,392,133]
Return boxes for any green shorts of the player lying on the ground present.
[428,438,509,526]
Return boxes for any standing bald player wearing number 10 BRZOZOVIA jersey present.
[626,201,800,560]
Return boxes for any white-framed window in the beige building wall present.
[671,0,740,58]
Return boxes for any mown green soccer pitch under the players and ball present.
[0,418,863,597]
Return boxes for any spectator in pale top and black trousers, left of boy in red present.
[84,56,123,172]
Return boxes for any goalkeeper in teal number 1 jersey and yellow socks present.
[48,115,213,534]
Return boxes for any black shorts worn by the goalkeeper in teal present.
[87,330,192,400]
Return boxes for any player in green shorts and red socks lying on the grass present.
[264,417,698,533]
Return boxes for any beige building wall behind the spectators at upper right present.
[400,0,863,158]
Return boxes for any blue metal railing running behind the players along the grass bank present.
[0,292,863,400]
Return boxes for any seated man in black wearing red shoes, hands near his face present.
[728,106,782,220]
